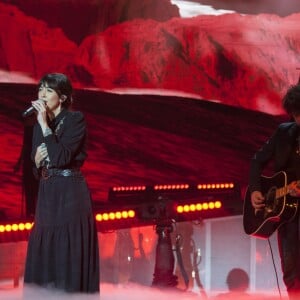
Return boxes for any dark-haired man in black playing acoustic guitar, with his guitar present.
[243,83,300,300]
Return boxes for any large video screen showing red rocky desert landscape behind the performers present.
[0,0,300,219]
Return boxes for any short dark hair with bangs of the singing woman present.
[38,73,73,108]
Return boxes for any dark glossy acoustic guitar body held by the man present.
[243,172,298,238]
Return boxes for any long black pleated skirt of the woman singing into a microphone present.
[24,176,99,293]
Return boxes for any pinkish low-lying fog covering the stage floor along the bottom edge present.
[0,281,288,300]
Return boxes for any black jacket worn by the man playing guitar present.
[249,122,299,192]
